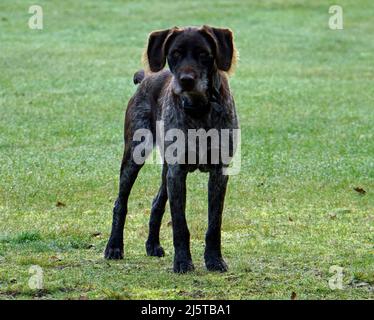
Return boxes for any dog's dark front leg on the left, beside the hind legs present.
[167,164,194,273]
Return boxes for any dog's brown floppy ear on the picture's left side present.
[146,27,178,72]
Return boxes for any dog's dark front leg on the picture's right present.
[204,167,228,272]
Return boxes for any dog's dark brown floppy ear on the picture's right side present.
[201,26,236,71]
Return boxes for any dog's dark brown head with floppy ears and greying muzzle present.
[146,26,236,94]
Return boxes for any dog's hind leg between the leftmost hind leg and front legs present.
[145,164,168,257]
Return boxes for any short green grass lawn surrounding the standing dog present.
[0,0,374,299]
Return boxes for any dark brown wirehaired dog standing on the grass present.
[104,26,239,273]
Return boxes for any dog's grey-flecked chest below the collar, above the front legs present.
[161,97,237,171]
